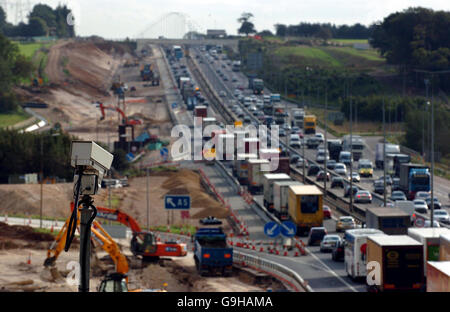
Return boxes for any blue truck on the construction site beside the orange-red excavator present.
[192,227,233,276]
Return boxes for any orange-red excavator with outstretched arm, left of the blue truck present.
[70,203,187,260]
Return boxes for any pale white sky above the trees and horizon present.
[0,0,450,39]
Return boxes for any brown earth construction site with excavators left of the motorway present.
[0,40,285,292]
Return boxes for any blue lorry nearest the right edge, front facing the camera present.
[399,163,431,200]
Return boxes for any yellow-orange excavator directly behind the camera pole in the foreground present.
[44,210,149,292]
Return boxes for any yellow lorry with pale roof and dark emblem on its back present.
[288,185,323,235]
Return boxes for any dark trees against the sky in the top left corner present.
[0,4,75,38]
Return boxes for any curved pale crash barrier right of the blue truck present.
[233,250,313,292]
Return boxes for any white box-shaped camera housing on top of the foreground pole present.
[70,141,114,195]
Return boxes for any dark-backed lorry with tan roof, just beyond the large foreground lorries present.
[366,208,411,235]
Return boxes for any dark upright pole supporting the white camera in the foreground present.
[78,195,97,292]
